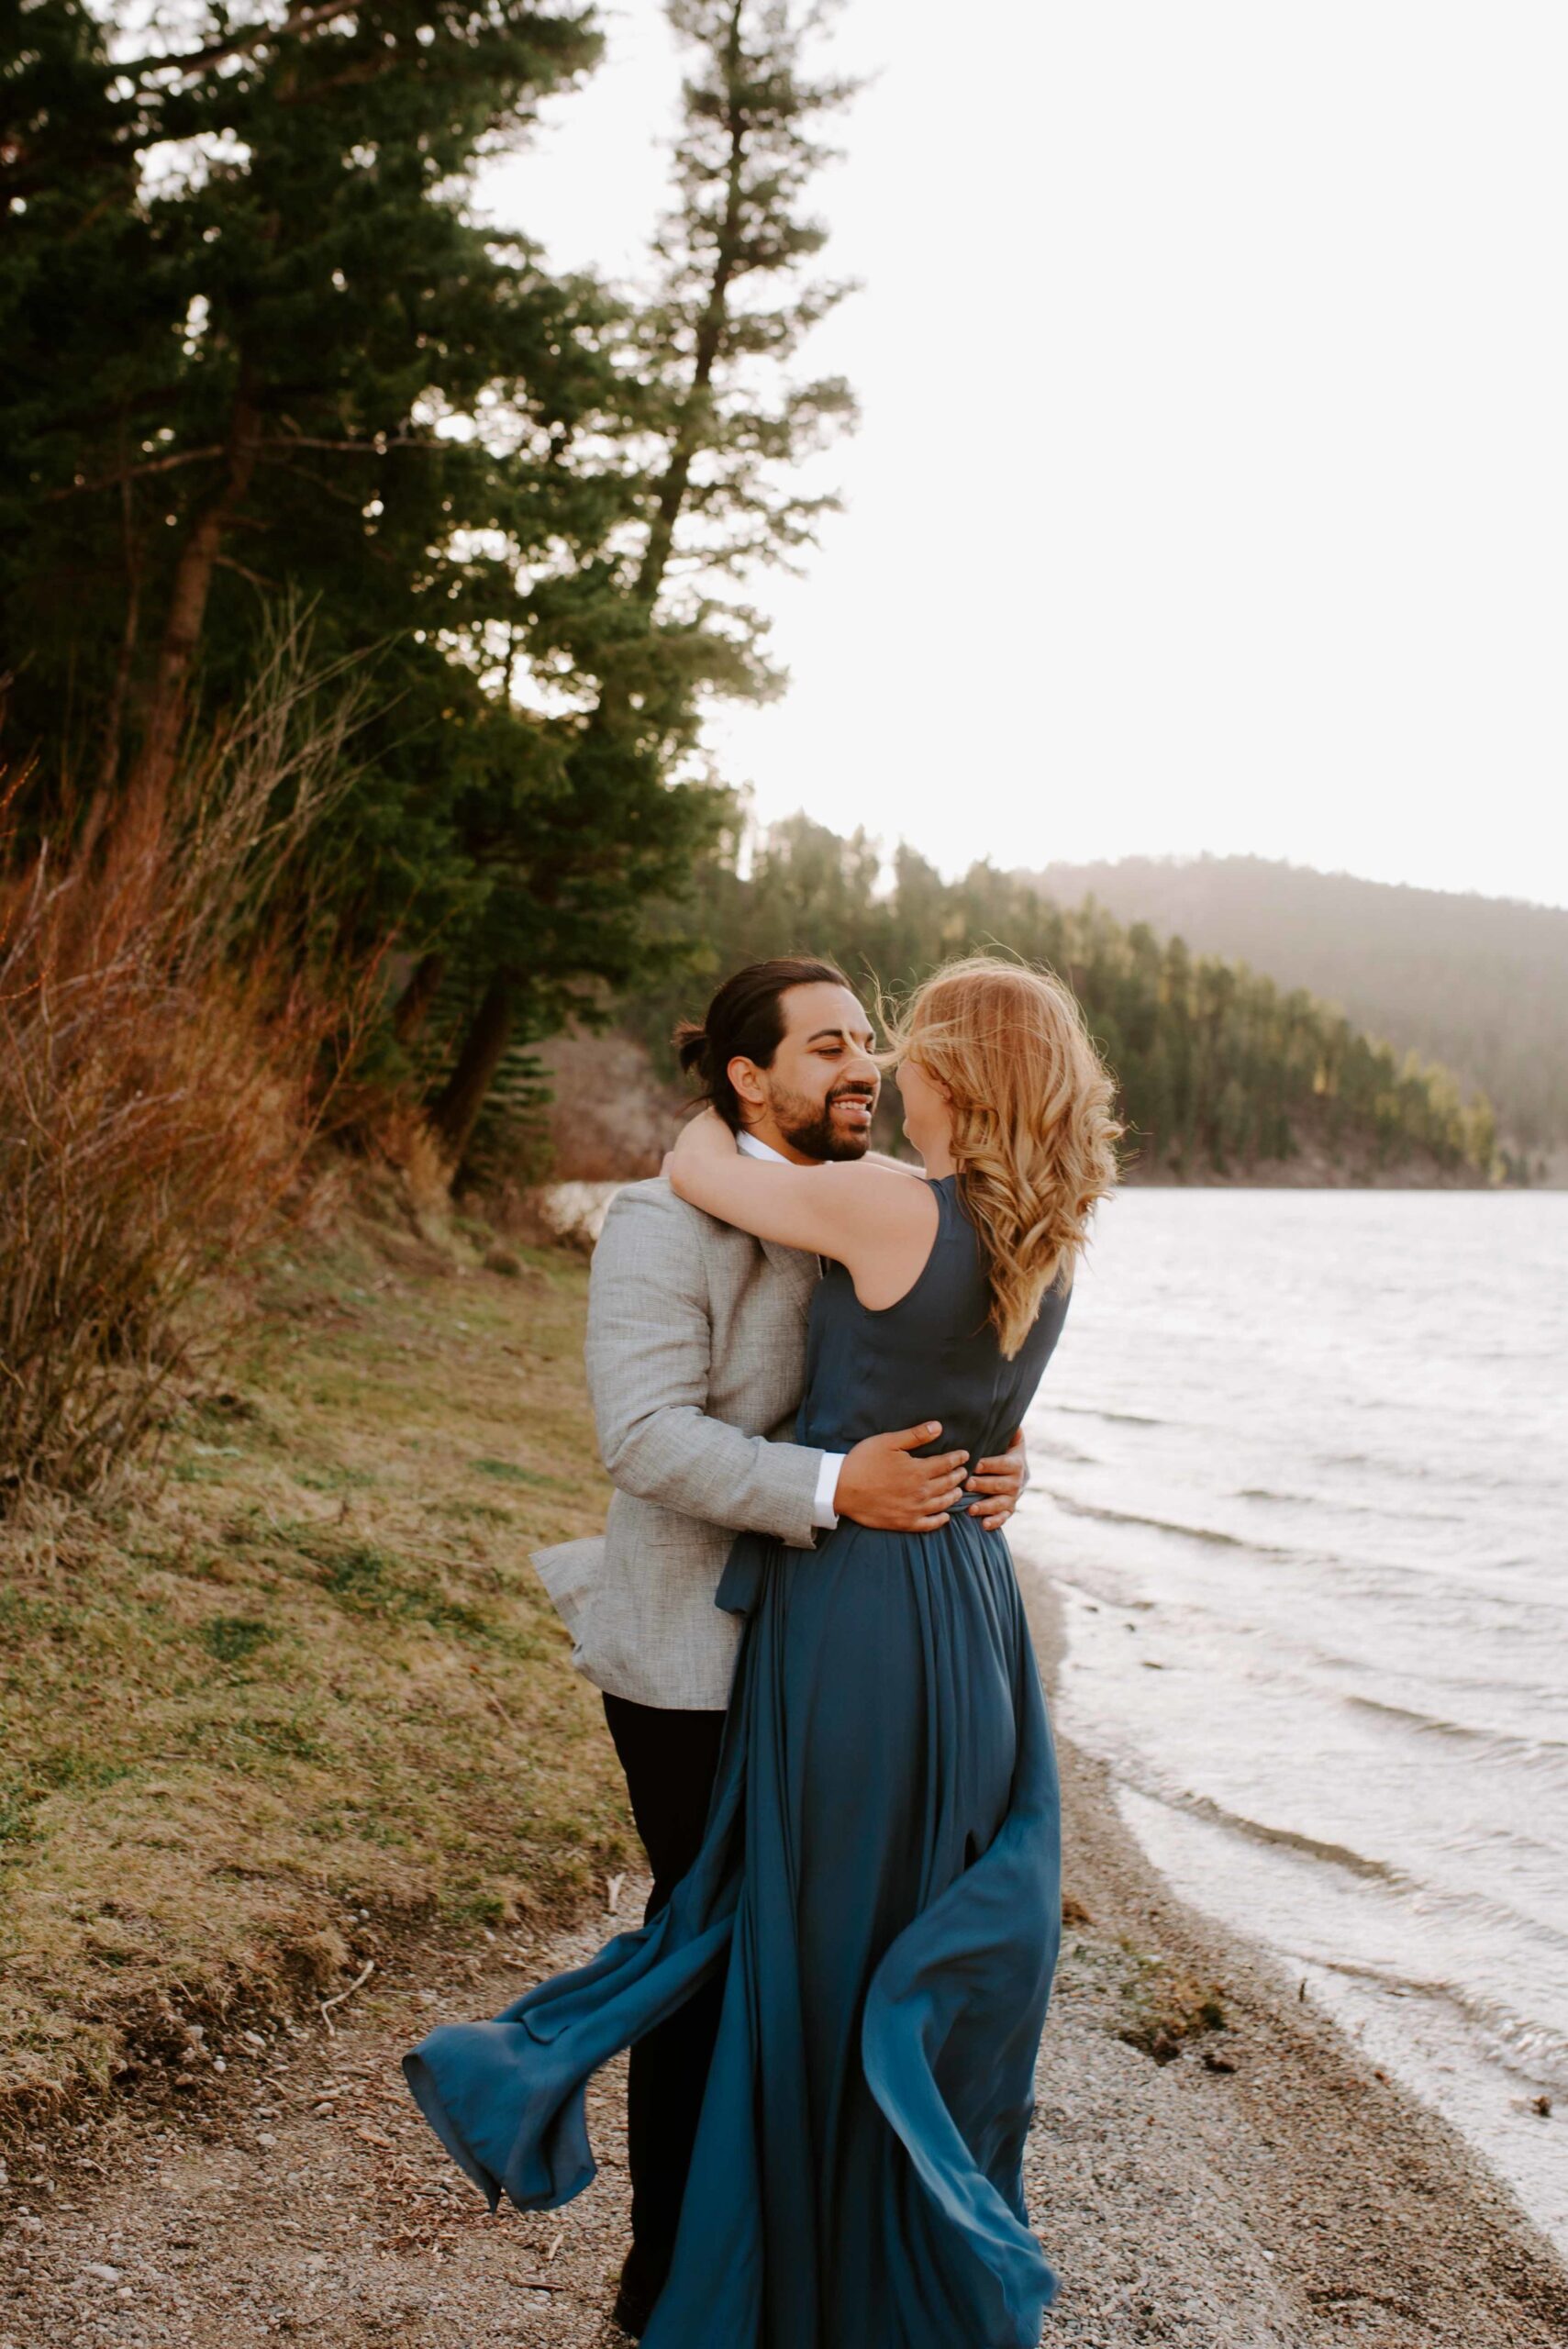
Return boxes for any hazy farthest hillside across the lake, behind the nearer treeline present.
[1033,857,1568,1158]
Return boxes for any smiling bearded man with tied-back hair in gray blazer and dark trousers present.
[535,956,1023,2335]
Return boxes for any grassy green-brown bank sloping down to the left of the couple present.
[0,1221,636,2138]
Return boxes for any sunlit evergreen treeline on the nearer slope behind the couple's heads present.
[627,818,1496,1179]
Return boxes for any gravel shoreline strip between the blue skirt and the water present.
[1017,1551,1568,2349]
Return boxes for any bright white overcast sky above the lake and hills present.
[481,0,1568,905]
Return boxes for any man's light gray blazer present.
[533,1177,821,1712]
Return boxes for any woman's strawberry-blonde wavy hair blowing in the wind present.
[880,953,1122,1360]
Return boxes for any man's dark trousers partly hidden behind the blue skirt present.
[604,1691,726,2309]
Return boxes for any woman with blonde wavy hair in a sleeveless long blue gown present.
[404,958,1118,2349]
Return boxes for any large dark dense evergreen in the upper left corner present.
[0,0,610,819]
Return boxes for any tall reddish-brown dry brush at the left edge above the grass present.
[0,628,364,1503]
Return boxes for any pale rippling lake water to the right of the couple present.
[1017,1191,1568,2250]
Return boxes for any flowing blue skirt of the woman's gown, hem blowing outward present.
[404,1515,1061,2349]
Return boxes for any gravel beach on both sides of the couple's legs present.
[0,1564,1568,2349]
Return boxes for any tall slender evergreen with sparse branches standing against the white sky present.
[413,0,852,1156]
